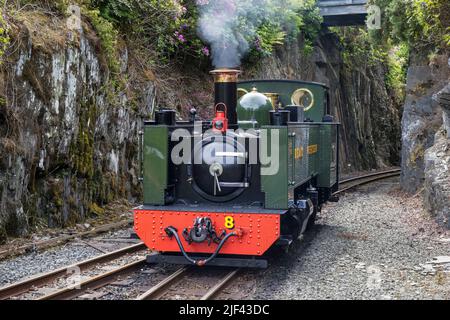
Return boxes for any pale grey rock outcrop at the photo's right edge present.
[401,53,450,227]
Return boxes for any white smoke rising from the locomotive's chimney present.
[195,0,321,68]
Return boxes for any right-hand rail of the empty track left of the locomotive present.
[36,258,147,300]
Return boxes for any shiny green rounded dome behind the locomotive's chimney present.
[237,91,273,129]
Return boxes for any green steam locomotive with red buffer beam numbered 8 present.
[134,69,339,268]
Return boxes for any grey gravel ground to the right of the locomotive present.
[229,181,450,300]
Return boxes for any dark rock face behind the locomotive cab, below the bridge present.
[248,30,401,170]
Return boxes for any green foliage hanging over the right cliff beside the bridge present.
[333,0,450,105]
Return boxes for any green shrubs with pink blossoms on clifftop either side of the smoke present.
[89,0,321,63]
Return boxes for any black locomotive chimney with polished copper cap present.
[211,69,241,129]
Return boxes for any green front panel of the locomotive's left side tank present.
[143,126,169,205]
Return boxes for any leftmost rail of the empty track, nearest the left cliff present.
[0,243,146,300]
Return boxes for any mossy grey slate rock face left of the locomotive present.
[0,12,154,239]
